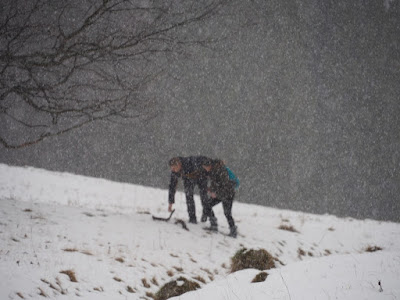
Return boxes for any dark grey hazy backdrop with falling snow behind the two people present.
[0,0,400,222]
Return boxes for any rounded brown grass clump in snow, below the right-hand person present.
[231,248,275,273]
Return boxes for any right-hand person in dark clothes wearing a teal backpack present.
[203,159,237,238]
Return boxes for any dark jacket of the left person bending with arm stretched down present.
[168,156,210,203]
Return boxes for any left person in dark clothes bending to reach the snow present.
[168,156,209,224]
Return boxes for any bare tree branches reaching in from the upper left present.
[0,0,224,148]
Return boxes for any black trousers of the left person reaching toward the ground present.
[183,178,208,220]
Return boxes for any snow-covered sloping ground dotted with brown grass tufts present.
[0,164,400,300]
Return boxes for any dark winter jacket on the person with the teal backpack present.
[207,159,235,201]
